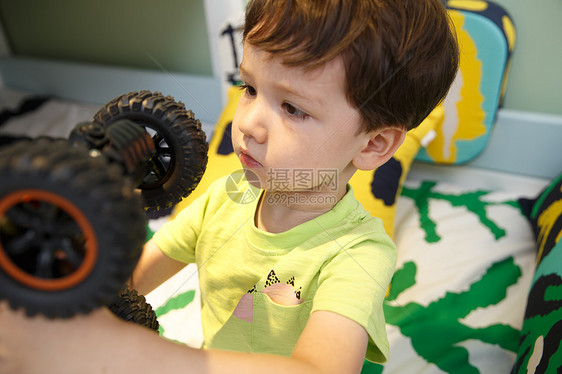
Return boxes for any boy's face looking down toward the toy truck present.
[232,43,369,192]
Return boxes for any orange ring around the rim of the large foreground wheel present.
[0,189,98,291]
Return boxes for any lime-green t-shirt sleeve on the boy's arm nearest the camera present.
[312,234,396,363]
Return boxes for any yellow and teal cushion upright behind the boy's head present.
[416,0,515,164]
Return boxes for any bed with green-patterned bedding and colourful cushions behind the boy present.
[0,2,562,374]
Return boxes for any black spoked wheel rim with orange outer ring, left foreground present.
[0,189,98,291]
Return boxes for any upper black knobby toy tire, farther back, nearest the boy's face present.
[94,90,208,213]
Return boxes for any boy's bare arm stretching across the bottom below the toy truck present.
[0,302,368,374]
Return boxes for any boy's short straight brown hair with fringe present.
[244,0,459,131]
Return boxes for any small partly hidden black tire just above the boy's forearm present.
[109,287,159,331]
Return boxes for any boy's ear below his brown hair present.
[353,127,407,170]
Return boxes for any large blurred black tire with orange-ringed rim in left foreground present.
[0,139,146,317]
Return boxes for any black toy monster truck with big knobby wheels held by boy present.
[0,91,207,317]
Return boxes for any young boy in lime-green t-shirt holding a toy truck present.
[0,0,458,373]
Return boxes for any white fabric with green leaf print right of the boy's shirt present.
[363,181,536,374]
